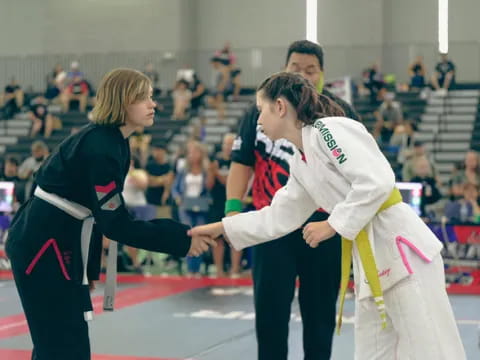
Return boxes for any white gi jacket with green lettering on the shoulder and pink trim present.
[222,117,442,300]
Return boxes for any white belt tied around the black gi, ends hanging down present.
[34,186,117,321]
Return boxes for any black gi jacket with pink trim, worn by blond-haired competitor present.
[6,124,191,282]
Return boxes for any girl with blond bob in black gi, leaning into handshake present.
[6,69,214,360]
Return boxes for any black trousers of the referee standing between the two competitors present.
[253,214,341,360]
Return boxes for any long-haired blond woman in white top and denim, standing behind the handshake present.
[172,141,214,276]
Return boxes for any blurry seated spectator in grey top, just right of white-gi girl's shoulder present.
[373,93,403,144]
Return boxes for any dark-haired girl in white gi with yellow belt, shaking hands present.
[191,73,465,360]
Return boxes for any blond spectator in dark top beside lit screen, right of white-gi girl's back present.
[410,156,442,220]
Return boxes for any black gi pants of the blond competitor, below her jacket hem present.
[12,249,90,360]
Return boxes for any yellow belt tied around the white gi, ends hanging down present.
[337,188,402,333]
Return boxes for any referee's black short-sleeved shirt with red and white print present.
[232,89,360,209]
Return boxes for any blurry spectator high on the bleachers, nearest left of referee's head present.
[208,56,231,119]
